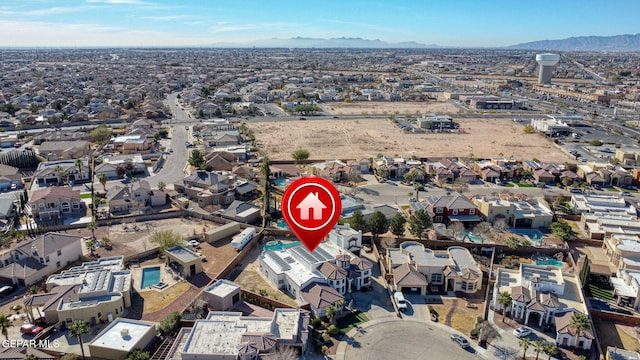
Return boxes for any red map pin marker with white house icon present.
[280,176,342,251]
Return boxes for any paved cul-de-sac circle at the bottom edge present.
[335,319,482,360]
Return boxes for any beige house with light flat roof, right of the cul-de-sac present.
[491,263,587,330]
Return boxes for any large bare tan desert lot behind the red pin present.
[249,118,575,162]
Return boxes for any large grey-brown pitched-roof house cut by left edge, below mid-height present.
[0,232,82,286]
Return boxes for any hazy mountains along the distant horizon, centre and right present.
[206,33,640,51]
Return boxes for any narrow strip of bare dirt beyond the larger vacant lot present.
[323,101,459,116]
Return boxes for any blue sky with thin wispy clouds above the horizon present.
[0,0,640,47]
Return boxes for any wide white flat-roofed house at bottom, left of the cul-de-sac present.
[167,309,311,360]
